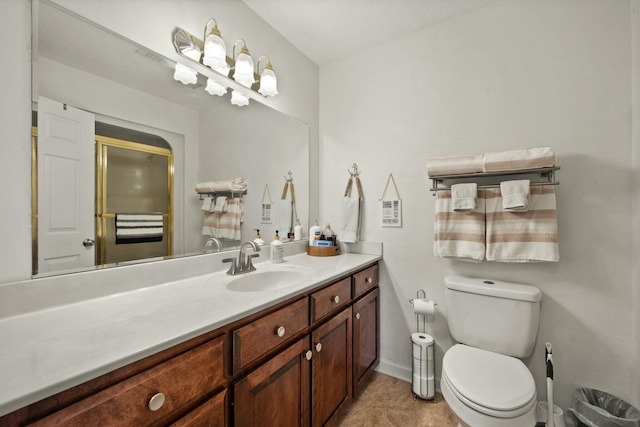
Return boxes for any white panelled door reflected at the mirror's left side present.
[37,97,95,273]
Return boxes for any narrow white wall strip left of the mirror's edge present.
[0,0,31,282]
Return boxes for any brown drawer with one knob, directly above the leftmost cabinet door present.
[233,298,309,374]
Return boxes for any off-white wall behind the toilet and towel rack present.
[320,0,638,416]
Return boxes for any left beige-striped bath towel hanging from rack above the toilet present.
[433,189,485,262]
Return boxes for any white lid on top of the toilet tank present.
[444,276,542,302]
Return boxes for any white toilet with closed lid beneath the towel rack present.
[440,276,542,427]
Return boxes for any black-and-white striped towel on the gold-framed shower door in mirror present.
[116,212,164,245]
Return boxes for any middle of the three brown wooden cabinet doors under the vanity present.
[311,307,353,426]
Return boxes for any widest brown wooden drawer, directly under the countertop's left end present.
[31,336,224,427]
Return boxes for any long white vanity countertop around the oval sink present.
[0,247,381,416]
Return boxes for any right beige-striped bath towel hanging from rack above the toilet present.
[486,185,560,262]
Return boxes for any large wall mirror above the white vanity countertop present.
[32,0,309,277]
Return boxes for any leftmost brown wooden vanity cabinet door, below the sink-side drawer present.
[233,338,311,427]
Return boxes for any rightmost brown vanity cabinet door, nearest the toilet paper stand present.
[353,289,380,396]
